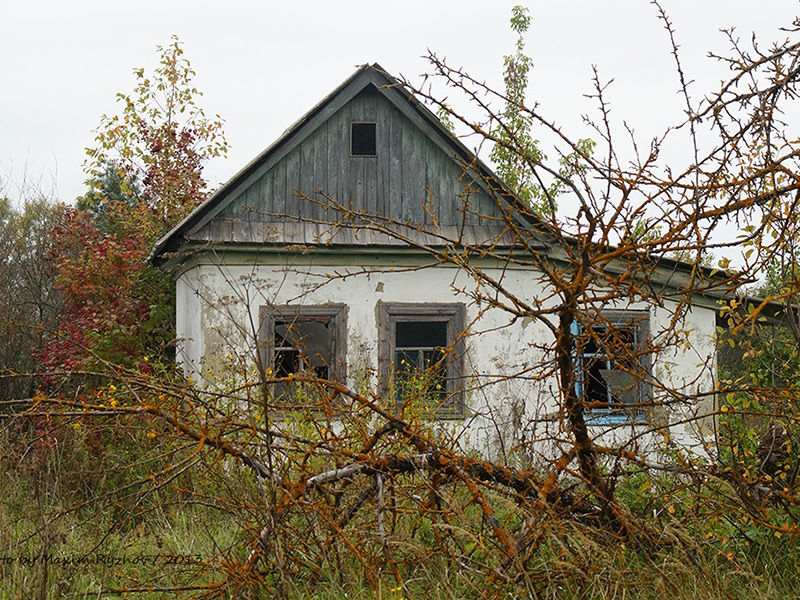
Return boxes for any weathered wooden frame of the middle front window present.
[378,302,466,419]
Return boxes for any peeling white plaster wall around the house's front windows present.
[177,255,715,457]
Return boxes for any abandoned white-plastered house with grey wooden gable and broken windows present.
[151,65,718,458]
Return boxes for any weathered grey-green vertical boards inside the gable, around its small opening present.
[191,85,502,244]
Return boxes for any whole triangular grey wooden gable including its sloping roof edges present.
[151,65,541,259]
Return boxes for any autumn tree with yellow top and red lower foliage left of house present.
[42,37,227,371]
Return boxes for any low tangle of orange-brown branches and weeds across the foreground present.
[1,356,795,597]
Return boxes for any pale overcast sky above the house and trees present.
[0,0,800,201]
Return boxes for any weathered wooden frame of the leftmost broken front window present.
[258,304,347,408]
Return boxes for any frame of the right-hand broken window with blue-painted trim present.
[572,310,651,425]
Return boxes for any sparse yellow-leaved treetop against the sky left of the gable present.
[85,36,228,236]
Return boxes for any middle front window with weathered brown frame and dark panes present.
[378,303,465,418]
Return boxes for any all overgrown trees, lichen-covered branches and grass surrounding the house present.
[0,7,800,598]
